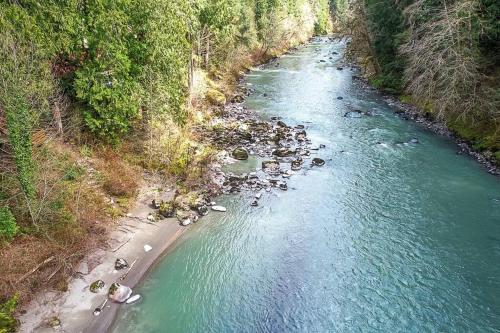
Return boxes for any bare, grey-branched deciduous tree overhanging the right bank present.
[400,0,495,119]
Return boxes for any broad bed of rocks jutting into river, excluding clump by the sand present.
[200,85,325,202]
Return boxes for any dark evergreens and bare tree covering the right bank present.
[332,0,500,164]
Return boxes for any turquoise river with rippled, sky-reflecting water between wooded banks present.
[112,38,500,333]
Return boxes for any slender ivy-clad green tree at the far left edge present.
[0,3,53,199]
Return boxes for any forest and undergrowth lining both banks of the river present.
[0,0,500,332]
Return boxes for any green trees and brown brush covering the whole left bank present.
[0,0,330,331]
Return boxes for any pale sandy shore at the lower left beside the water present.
[19,187,187,333]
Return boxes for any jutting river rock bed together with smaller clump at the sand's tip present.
[144,84,325,226]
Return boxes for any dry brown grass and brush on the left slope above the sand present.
[0,141,139,304]
